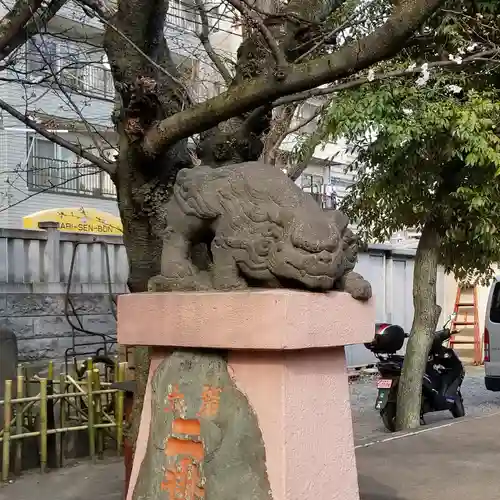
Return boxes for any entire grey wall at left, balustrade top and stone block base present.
[0,229,128,361]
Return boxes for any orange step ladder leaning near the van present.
[449,285,482,365]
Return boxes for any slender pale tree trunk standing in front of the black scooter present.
[396,222,441,430]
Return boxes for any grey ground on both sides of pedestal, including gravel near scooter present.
[0,368,500,500]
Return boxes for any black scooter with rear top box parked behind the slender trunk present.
[365,315,465,432]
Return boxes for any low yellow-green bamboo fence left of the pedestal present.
[0,359,127,482]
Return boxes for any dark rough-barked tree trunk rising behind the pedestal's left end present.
[104,0,191,454]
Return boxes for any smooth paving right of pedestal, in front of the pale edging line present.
[356,413,500,500]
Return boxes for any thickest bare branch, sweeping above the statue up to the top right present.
[143,0,444,156]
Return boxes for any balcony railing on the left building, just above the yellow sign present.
[27,156,116,199]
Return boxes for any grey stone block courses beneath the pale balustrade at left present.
[0,293,116,362]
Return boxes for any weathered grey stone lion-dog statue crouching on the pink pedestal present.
[150,162,371,300]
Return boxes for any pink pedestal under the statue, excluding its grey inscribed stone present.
[118,290,375,500]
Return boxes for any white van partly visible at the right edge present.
[483,276,500,392]
